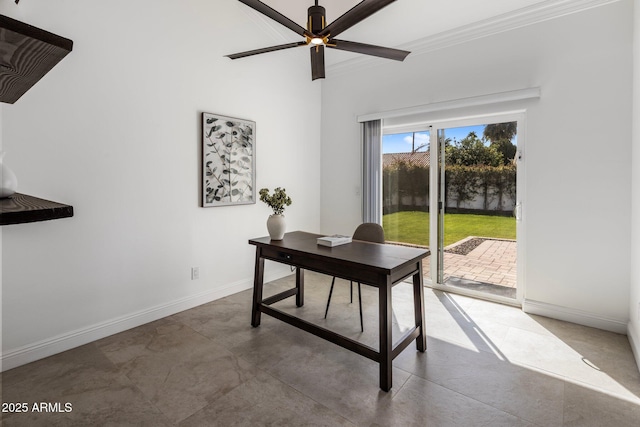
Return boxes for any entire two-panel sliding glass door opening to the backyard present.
[382,114,523,302]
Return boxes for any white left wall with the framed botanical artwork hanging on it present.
[0,0,320,369]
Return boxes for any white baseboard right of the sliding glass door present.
[522,299,627,335]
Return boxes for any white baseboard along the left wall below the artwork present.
[0,267,291,372]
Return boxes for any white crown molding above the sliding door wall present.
[327,0,620,75]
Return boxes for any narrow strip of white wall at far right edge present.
[628,0,640,367]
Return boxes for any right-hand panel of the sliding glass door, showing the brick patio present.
[436,121,518,300]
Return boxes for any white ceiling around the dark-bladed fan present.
[238,0,616,66]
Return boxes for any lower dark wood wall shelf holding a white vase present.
[0,193,73,225]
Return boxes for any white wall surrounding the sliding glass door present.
[321,0,632,332]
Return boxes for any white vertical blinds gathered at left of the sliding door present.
[361,120,382,224]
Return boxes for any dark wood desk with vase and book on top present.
[249,231,429,391]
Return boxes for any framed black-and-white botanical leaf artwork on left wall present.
[202,113,256,207]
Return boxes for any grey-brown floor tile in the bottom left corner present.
[2,344,171,426]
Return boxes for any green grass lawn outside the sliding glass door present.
[382,211,516,246]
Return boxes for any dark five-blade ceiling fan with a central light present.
[226,0,411,80]
